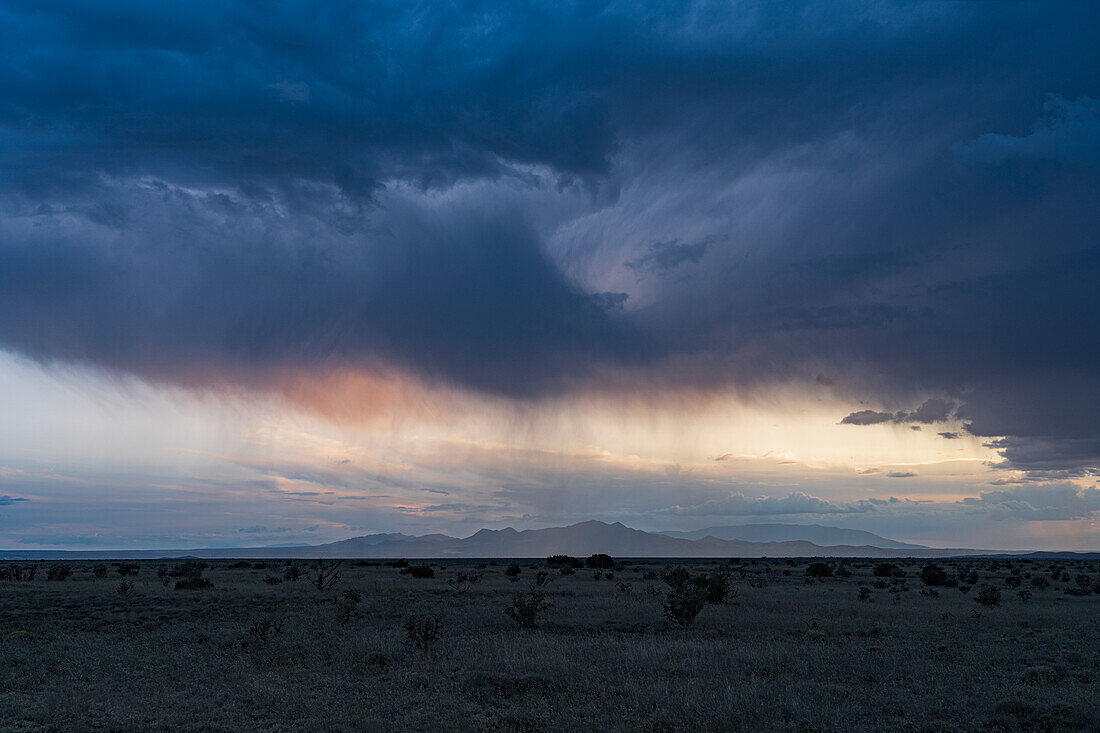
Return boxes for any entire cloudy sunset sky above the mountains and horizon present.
[0,0,1100,550]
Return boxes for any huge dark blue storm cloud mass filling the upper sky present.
[0,2,1100,470]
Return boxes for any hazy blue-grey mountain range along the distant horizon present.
[0,519,1095,559]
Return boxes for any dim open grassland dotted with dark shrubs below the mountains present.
[0,560,1100,731]
